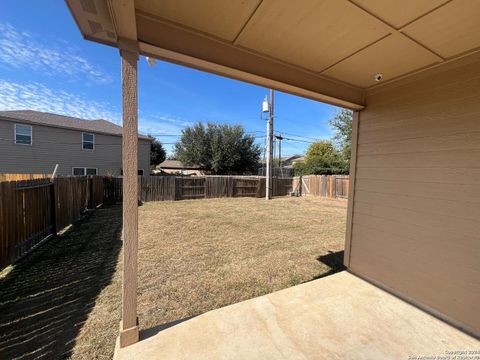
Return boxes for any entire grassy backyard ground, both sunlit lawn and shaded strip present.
[0,197,347,359]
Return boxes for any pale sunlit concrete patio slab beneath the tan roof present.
[115,272,480,360]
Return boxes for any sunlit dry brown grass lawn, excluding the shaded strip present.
[74,198,346,359]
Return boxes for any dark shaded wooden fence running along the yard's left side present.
[0,177,109,268]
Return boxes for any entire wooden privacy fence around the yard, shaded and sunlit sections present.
[0,176,348,269]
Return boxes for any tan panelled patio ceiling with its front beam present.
[66,0,480,109]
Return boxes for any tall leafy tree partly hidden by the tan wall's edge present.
[330,109,353,171]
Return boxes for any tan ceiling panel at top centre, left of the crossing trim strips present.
[236,0,389,72]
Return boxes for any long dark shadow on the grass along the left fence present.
[0,207,122,359]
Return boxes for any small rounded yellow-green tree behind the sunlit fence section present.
[294,140,345,176]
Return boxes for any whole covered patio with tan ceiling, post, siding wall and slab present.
[66,0,480,359]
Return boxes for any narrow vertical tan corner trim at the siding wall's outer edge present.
[343,111,360,267]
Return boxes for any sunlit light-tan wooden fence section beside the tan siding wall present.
[293,175,349,199]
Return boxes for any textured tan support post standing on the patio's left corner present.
[119,50,138,348]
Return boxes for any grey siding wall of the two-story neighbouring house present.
[0,119,150,176]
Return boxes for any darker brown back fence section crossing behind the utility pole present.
[139,175,292,202]
